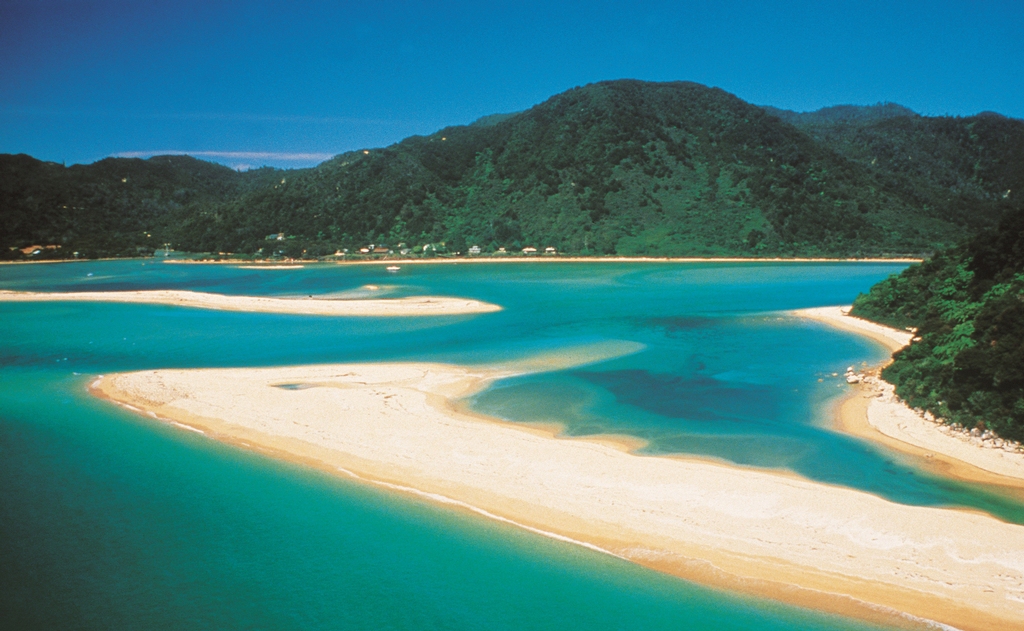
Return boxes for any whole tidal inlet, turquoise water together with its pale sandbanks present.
[6,259,1024,630]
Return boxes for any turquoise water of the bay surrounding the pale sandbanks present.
[0,261,1024,630]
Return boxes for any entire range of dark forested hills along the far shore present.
[0,80,1024,258]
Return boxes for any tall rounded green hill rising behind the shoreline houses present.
[169,81,1024,256]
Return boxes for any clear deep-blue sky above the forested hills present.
[0,0,1024,166]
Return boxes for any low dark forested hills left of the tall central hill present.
[0,155,273,258]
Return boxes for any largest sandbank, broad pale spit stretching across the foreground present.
[93,364,1024,630]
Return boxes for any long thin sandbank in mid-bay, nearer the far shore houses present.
[0,290,502,317]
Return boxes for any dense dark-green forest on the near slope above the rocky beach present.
[853,204,1024,440]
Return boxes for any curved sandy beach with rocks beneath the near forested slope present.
[793,306,1024,488]
